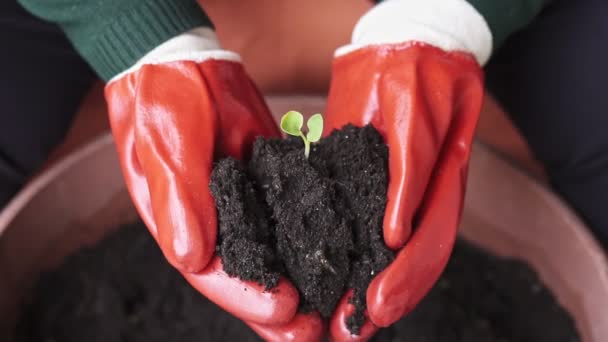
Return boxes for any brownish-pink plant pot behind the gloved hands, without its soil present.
[0,97,608,342]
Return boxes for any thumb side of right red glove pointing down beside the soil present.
[325,44,458,249]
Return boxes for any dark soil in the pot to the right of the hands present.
[374,241,580,342]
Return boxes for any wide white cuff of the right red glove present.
[335,0,492,65]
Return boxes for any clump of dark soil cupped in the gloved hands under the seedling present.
[210,125,394,333]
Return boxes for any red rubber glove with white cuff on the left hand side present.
[105,29,323,341]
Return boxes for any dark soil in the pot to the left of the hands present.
[17,223,259,342]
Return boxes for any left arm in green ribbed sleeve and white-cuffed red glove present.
[20,0,323,341]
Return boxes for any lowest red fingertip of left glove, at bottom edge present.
[245,314,325,342]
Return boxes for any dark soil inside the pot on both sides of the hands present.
[18,223,580,342]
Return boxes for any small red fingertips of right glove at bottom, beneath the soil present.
[329,290,378,342]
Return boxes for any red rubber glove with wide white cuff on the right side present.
[325,0,491,341]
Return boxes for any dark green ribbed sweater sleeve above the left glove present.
[19,0,212,81]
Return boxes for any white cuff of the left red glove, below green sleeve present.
[108,27,241,84]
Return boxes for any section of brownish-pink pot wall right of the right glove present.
[459,143,608,342]
